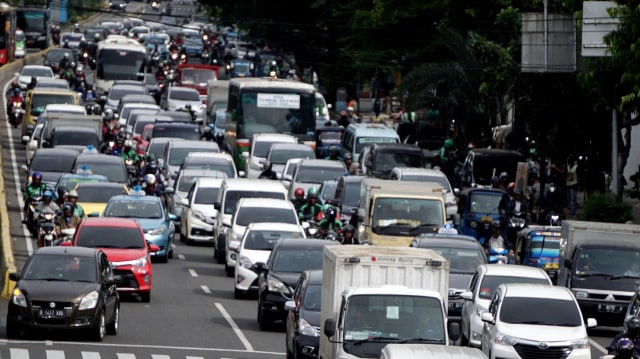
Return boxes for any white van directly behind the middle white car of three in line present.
[213,178,287,264]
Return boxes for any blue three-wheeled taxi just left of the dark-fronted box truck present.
[515,226,561,282]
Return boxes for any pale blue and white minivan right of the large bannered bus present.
[340,123,400,162]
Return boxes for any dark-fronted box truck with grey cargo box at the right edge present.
[557,221,640,326]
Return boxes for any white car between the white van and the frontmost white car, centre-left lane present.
[224,198,300,277]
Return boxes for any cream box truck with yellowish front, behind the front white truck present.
[358,178,447,247]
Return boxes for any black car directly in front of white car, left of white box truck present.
[255,238,339,330]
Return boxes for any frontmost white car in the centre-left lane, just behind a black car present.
[233,222,306,299]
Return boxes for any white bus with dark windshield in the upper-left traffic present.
[91,35,147,96]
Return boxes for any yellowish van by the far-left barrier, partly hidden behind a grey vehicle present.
[22,88,80,143]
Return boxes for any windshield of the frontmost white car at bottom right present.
[500,296,583,327]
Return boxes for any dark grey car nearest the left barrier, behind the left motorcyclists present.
[21,148,78,188]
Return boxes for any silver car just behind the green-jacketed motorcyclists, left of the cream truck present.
[289,159,347,198]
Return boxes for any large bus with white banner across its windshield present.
[224,77,316,171]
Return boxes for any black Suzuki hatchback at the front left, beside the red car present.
[6,247,120,341]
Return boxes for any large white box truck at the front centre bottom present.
[319,246,460,359]
